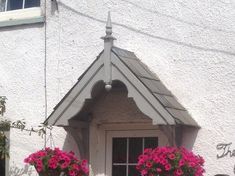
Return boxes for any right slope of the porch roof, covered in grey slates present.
[112,47,197,126]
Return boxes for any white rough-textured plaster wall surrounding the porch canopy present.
[0,0,235,176]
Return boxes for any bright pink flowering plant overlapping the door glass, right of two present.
[136,147,205,176]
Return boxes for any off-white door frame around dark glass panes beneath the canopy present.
[105,129,168,176]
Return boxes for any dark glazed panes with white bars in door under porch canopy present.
[112,137,158,176]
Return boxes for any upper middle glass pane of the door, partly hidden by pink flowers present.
[129,138,143,163]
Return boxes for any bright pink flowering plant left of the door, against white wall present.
[24,148,89,176]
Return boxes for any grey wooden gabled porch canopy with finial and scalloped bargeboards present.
[45,14,198,127]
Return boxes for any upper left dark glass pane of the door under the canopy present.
[113,138,127,163]
